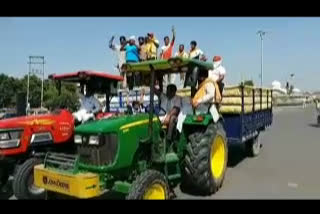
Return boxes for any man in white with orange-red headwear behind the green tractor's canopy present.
[209,56,226,93]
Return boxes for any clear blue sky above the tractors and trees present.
[0,17,320,90]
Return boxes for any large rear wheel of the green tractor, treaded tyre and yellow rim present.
[180,122,228,195]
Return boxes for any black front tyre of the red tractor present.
[12,158,45,199]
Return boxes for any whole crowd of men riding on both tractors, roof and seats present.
[74,27,226,129]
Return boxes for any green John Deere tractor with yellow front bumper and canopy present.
[34,58,228,199]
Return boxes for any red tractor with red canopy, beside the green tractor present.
[0,71,123,199]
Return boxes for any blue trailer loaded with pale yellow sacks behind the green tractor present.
[177,84,273,156]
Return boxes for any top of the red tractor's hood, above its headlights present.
[0,111,72,129]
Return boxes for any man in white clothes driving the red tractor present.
[73,84,102,123]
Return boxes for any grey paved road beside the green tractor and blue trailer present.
[6,107,320,199]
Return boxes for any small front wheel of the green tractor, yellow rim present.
[126,170,170,200]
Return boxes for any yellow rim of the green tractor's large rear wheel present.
[211,135,226,179]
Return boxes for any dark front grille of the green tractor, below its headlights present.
[77,134,118,166]
